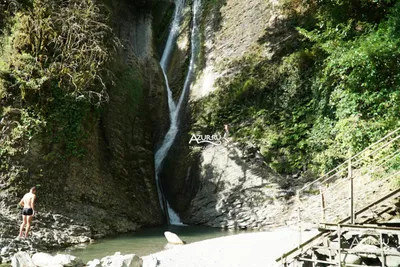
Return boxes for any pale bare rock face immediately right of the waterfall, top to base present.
[162,0,294,229]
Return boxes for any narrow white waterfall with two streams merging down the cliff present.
[155,0,201,225]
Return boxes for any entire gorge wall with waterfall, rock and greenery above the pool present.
[0,0,400,263]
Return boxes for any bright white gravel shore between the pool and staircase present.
[143,228,317,267]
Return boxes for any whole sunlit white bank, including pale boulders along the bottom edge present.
[8,228,317,267]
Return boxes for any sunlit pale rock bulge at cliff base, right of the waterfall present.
[182,143,294,229]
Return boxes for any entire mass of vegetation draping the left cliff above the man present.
[0,0,130,181]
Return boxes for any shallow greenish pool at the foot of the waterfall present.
[62,226,242,262]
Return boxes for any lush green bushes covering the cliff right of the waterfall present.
[193,0,400,174]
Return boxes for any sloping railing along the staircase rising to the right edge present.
[297,128,400,227]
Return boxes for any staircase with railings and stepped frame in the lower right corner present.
[276,128,400,267]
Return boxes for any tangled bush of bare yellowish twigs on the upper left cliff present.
[10,0,119,103]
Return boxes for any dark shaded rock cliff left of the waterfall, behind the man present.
[0,0,173,249]
